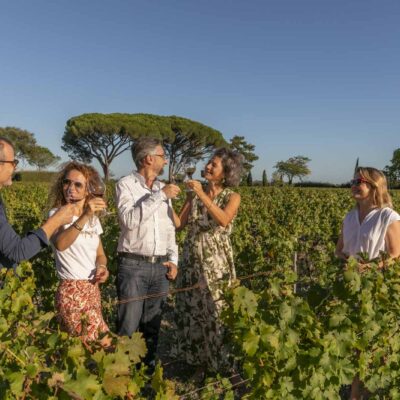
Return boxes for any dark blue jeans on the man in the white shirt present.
[117,256,169,364]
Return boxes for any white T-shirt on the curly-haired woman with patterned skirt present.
[49,209,103,280]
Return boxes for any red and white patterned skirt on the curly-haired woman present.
[56,279,109,341]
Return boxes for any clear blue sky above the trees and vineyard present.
[0,0,400,182]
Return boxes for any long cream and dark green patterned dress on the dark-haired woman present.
[171,188,236,371]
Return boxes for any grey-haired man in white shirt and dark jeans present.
[116,138,180,369]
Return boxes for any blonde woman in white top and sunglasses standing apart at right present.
[336,167,400,400]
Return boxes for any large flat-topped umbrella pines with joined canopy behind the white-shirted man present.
[62,113,226,179]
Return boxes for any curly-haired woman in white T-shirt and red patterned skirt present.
[50,161,109,345]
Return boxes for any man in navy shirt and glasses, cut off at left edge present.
[0,137,74,268]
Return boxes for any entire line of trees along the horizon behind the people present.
[10,113,400,187]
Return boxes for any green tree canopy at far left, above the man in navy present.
[0,126,60,169]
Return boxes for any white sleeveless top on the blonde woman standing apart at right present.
[343,207,400,259]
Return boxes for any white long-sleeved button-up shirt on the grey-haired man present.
[116,172,178,265]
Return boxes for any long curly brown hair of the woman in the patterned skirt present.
[48,161,101,208]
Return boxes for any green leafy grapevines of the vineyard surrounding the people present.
[0,183,400,400]
